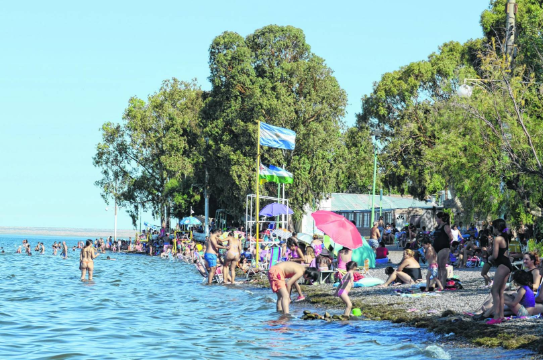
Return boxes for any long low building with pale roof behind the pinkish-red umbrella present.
[299,193,442,236]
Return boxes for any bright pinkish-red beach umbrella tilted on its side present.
[311,210,363,250]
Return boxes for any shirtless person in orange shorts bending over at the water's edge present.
[268,261,319,314]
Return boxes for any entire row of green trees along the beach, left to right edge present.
[94,0,543,235]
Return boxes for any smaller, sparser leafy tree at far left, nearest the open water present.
[93,78,203,226]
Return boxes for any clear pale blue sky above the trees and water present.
[0,0,489,229]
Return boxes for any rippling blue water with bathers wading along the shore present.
[0,235,527,360]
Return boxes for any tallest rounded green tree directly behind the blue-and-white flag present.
[203,25,347,218]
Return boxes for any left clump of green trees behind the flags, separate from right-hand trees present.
[94,25,373,228]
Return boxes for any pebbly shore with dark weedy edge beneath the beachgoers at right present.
[246,251,543,359]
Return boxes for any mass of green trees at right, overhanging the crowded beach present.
[357,0,543,231]
